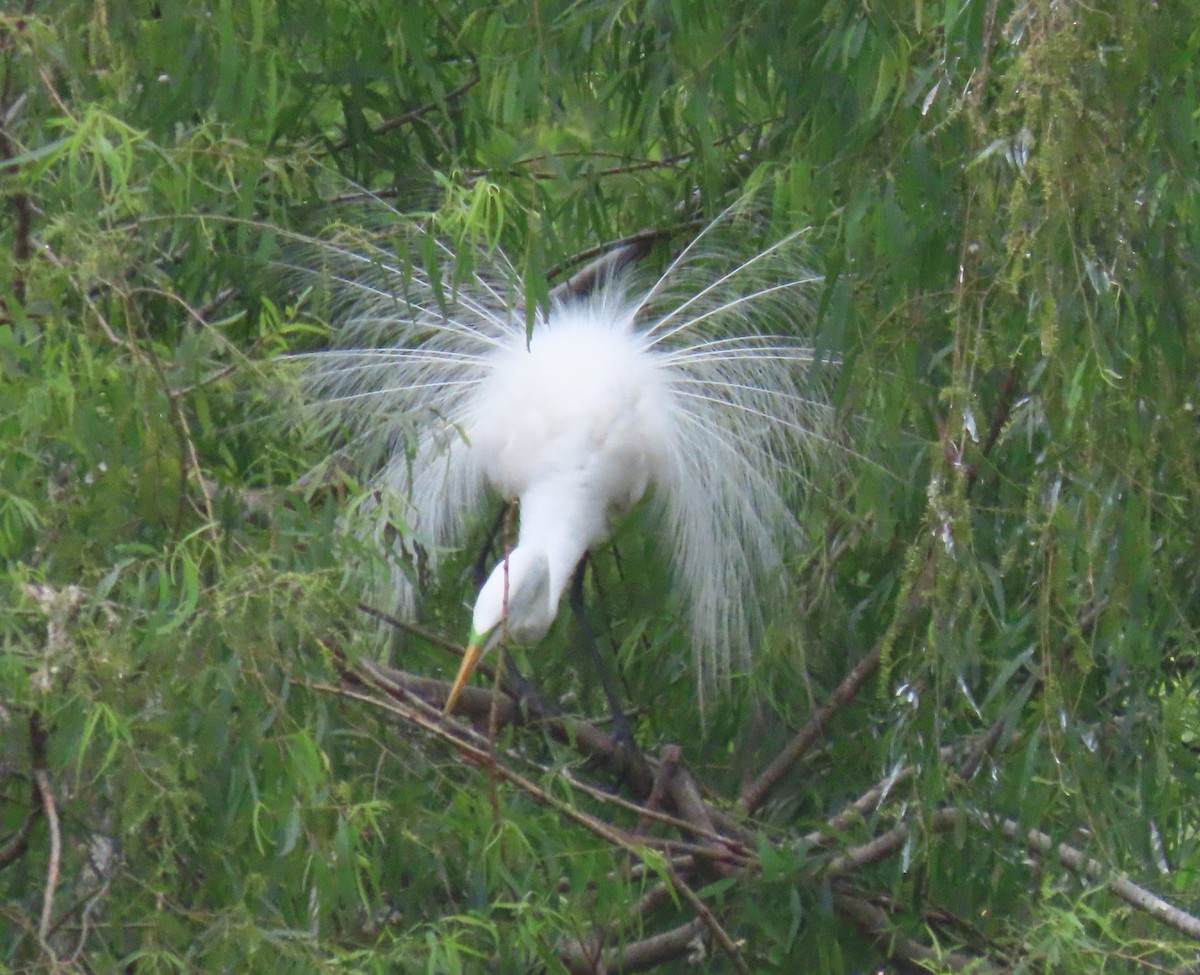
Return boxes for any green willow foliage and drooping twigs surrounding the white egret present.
[0,0,1200,973]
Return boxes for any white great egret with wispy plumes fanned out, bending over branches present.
[292,195,828,713]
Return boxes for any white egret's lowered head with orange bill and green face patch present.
[445,545,557,714]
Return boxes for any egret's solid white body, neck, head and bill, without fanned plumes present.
[446,292,672,711]
